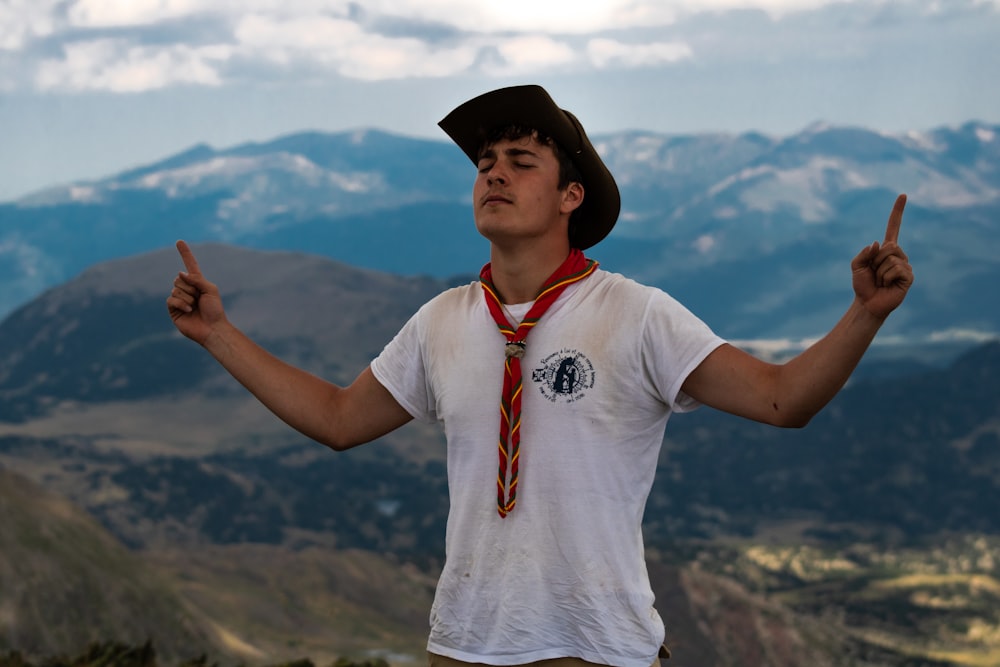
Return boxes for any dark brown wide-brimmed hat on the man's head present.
[438,85,621,250]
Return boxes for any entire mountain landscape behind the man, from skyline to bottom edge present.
[0,122,1000,667]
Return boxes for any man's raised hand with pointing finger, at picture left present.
[167,241,226,345]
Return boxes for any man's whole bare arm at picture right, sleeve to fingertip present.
[682,195,913,427]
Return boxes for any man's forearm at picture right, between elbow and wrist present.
[774,299,884,426]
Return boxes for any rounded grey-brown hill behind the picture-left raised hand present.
[0,244,446,420]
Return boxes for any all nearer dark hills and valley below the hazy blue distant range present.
[0,243,1000,666]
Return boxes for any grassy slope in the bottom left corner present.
[0,468,213,660]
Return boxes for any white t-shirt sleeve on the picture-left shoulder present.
[371,305,437,422]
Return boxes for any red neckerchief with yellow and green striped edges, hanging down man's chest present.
[479,248,597,518]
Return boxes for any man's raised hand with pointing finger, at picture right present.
[851,195,913,319]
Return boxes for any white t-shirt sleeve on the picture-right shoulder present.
[642,290,726,412]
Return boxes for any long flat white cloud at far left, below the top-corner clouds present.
[36,39,229,93]
